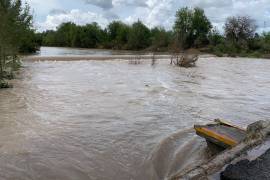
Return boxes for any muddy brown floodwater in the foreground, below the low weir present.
[0,47,270,180]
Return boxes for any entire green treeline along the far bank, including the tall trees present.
[36,8,270,56]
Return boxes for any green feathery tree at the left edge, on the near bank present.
[0,0,33,80]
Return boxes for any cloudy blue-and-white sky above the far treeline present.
[25,0,270,31]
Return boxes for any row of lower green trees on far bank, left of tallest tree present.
[38,21,173,50]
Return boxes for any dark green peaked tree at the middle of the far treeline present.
[128,21,151,50]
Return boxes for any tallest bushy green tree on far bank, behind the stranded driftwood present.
[173,7,212,49]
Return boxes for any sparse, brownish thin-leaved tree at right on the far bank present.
[224,16,257,48]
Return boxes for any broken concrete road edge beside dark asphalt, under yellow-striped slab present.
[169,121,270,180]
